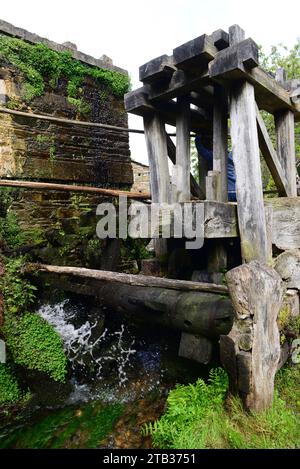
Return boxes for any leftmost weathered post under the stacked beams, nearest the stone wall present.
[144,114,170,257]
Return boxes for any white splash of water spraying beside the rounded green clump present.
[38,300,136,387]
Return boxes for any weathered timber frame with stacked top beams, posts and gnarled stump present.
[125,25,300,410]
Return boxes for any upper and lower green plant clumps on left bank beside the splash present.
[0,257,67,381]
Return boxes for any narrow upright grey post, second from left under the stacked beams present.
[176,96,191,202]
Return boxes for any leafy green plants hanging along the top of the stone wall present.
[0,35,129,104]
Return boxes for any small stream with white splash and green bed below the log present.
[0,297,216,448]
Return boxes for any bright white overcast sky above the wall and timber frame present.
[0,0,300,162]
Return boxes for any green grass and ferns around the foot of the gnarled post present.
[142,367,300,449]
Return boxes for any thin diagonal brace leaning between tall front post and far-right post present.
[256,106,292,197]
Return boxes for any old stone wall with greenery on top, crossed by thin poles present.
[0,21,134,227]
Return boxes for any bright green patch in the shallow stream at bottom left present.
[0,403,123,449]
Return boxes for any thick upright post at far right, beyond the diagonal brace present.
[275,110,297,197]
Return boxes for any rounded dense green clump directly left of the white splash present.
[2,313,67,382]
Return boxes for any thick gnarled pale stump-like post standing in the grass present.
[221,261,284,412]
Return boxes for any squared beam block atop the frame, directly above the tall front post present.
[208,38,259,78]
